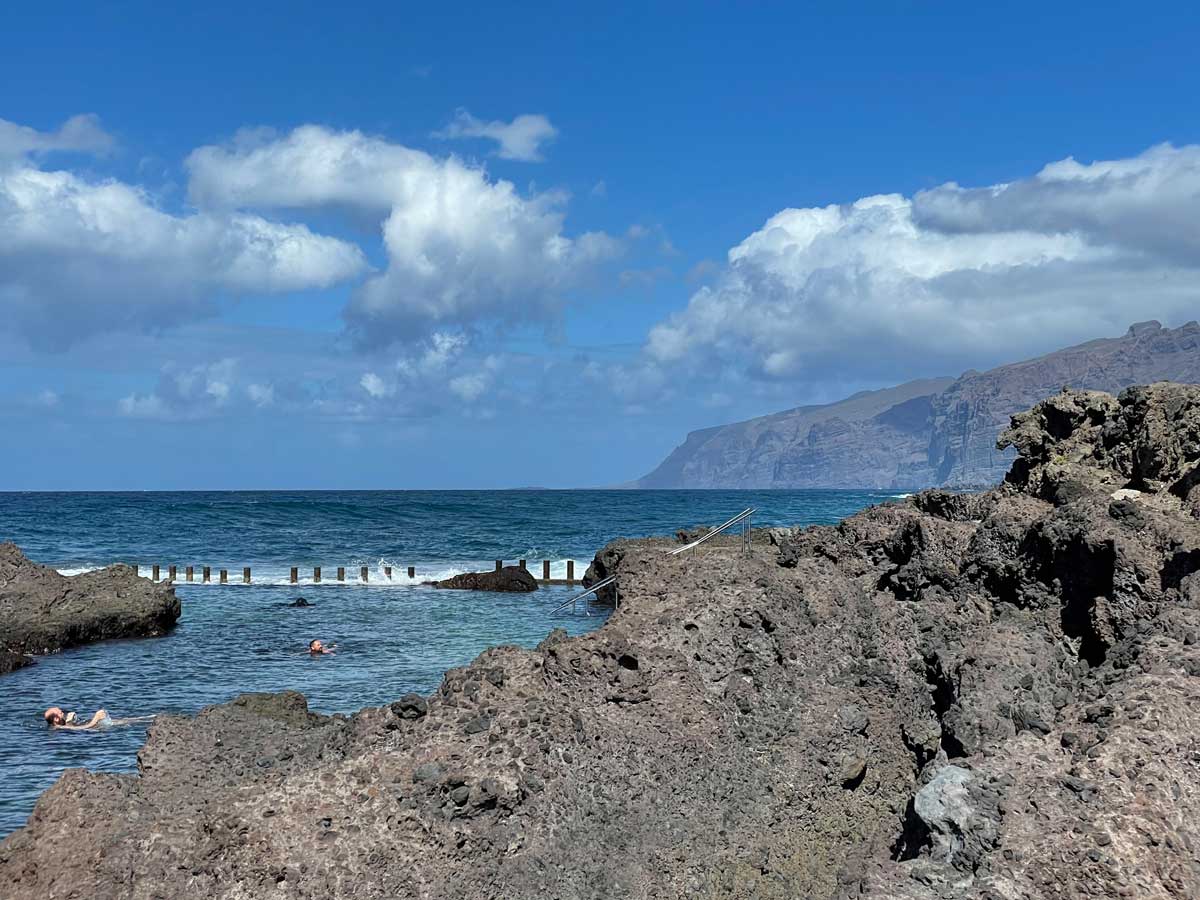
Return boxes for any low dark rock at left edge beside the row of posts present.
[0,544,180,674]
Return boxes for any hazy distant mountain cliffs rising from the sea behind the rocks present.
[635,322,1200,491]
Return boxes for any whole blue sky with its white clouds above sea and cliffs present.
[0,2,1200,490]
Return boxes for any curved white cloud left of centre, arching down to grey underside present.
[187,126,620,346]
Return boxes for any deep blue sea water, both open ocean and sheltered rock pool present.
[0,491,890,835]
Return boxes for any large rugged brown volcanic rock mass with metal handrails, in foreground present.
[0,384,1200,900]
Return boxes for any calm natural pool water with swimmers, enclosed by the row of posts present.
[0,584,604,836]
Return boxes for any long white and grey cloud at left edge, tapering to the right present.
[0,128,366,349]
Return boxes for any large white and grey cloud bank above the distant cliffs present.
[646,145,1200,379]
